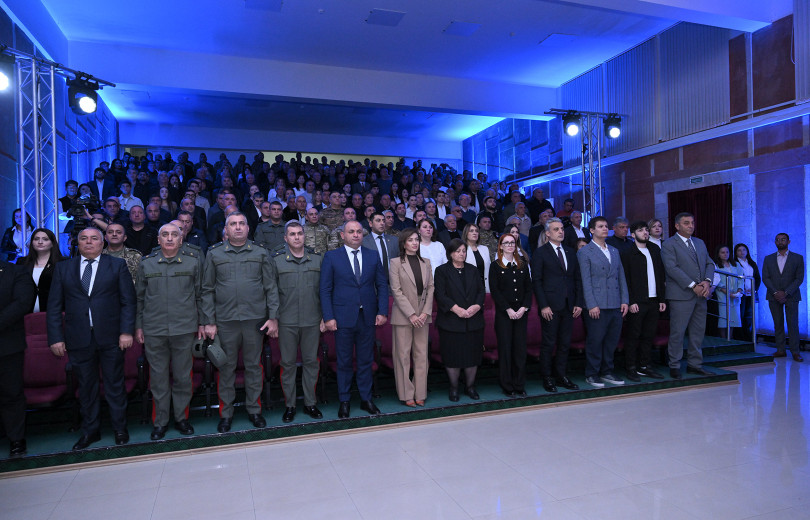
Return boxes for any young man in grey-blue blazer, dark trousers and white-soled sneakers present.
[577,217,629,388]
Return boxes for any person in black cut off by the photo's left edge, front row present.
[0,260,37,457]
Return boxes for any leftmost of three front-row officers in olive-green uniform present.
[135,224,203,441]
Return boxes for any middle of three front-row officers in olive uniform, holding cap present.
[202,212,278,433]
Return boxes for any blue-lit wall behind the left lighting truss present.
[0,6,118,233]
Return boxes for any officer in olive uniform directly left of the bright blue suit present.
[270,220,325,423]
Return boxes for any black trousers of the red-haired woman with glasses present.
[495,310,529,392]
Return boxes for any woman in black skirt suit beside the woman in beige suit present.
[433,238,484,402]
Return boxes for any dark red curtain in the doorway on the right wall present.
[668,184,734,259]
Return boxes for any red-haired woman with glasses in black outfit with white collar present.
[489,234,532,397]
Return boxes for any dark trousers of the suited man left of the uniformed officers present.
[68,332,127,435]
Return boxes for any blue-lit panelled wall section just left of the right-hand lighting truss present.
[462,119,562,185]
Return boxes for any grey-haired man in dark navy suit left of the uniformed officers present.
[48,228,136,450]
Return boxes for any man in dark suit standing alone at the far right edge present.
[762,233,804,363]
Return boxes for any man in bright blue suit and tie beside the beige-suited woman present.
[320,220,388,419]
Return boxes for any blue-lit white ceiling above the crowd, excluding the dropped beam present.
[38,0,792,139]
